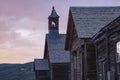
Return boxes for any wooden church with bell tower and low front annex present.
[34,7,70,80]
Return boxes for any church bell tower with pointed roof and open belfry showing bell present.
[48,7,59,34]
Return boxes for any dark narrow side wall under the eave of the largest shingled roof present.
[84,42,96,80]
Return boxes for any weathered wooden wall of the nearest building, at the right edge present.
[95,20,120,80]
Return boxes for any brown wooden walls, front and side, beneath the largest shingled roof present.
[70,26,96,80]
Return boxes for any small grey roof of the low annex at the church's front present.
[34,59,49,71]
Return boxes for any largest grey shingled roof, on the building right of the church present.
[68,7,120,38]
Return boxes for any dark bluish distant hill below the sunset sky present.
[0,62,35,80]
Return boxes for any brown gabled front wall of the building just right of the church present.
[70,26,84,80]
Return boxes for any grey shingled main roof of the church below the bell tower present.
[47,34,70,63]
